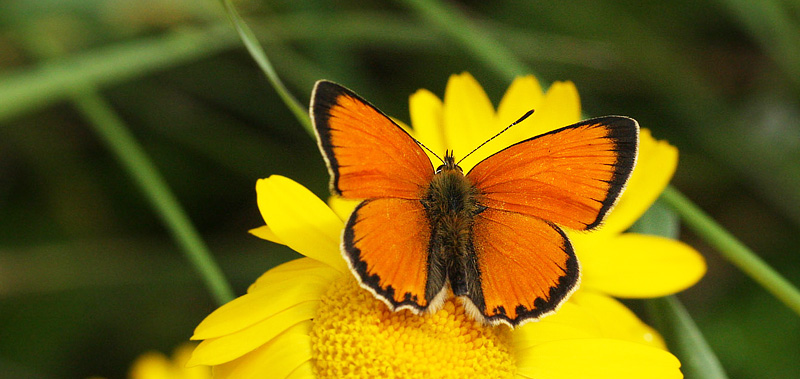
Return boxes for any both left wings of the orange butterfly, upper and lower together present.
[311,81,445,311]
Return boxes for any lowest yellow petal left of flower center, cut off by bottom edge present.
[214,321,311,379]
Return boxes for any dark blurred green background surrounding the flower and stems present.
[0,0,800,378]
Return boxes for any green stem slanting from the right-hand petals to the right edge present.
[661,186,800,314]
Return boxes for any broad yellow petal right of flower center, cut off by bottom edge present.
[517,338,683,379]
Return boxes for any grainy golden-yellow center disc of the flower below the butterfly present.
[311,275,515,379]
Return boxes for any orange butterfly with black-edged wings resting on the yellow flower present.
[310,81,639,327]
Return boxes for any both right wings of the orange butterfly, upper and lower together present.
[467,117,639,325]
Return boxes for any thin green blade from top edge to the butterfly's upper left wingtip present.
[221,0,314,137]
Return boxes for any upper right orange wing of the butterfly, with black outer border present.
[467,116,639,230]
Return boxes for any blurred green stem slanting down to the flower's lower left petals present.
[72,86,234,305]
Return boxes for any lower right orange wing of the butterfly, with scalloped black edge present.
[466,208,579,326]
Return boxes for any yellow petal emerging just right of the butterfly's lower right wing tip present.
[570,291,666,349]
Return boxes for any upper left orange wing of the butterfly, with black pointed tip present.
[311,81,433,199]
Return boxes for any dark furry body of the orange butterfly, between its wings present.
[420,153,485,297]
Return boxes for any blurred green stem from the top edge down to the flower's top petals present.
[396,0,531,81]
